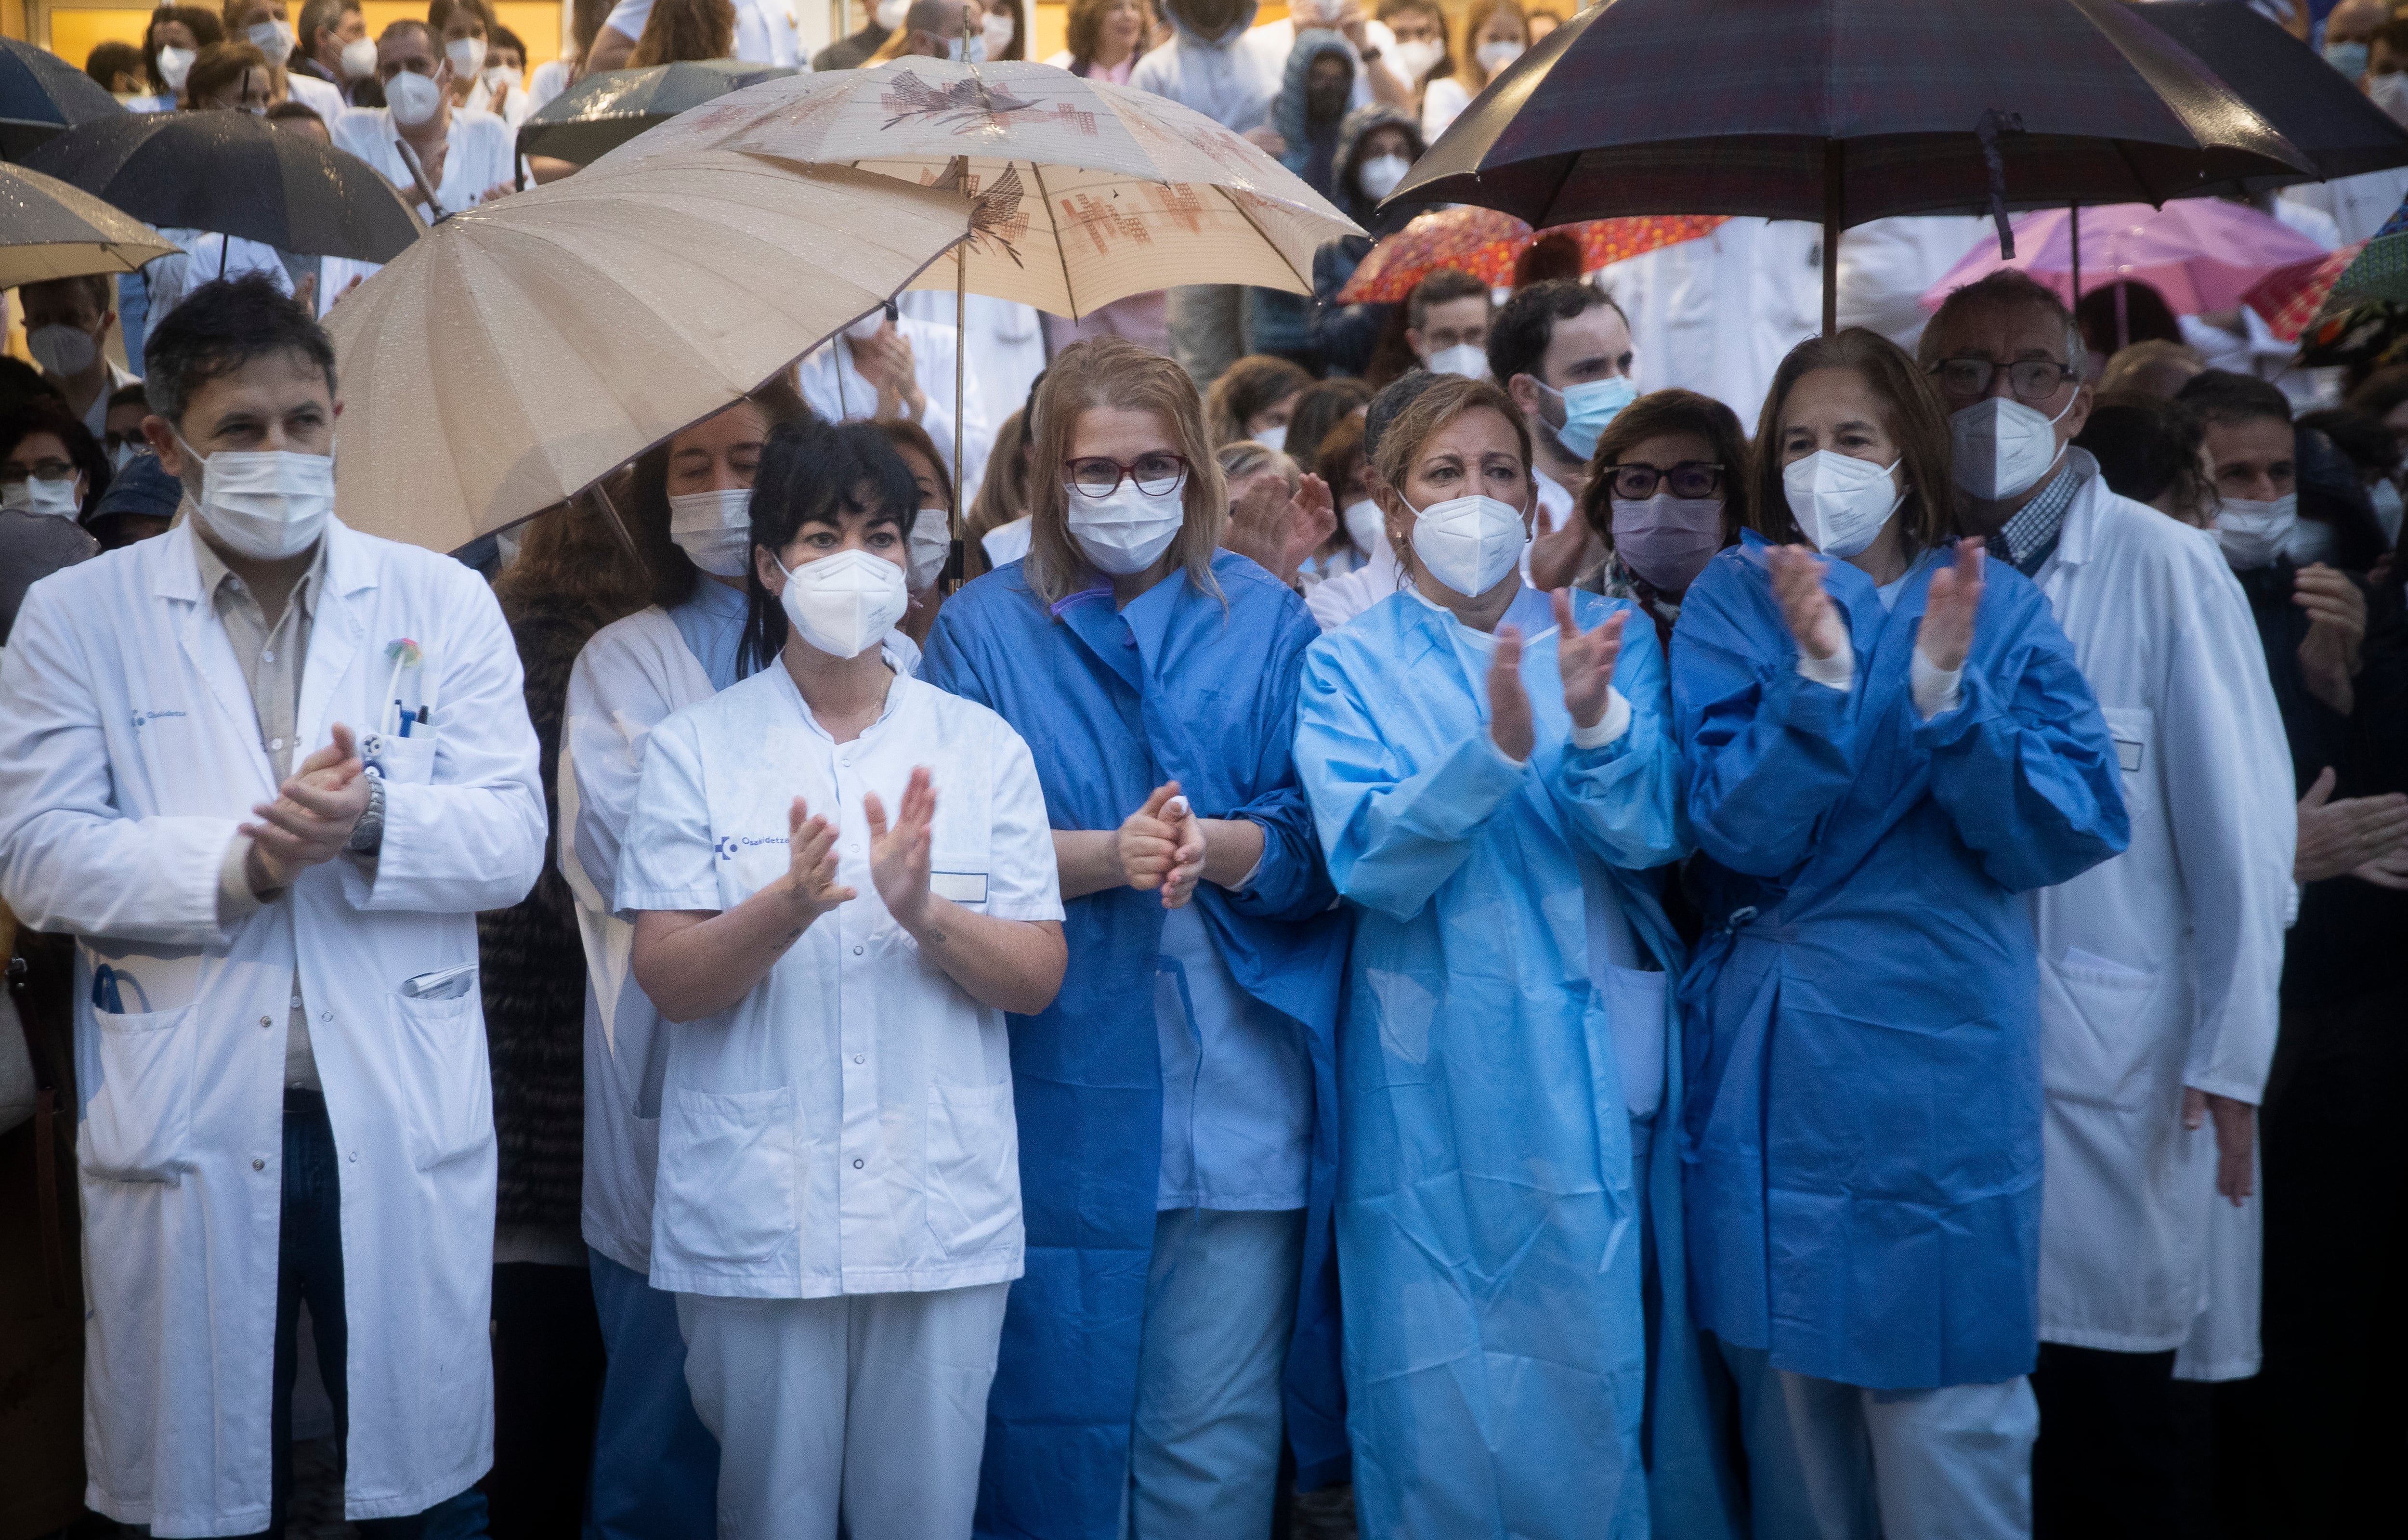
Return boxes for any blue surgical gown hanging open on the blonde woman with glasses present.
[925,551,1346,1540]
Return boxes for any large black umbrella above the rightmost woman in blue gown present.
[1394,0,2316,330]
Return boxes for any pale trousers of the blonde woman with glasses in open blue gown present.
[1122,1208,1305,1540]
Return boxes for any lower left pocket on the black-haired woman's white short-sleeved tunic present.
[653,1085,797,1268]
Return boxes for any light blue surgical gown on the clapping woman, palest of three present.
[1296,589,1727,1540]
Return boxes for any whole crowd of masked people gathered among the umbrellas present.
[0,0,2408,1540]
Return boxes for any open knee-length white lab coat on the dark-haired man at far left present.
[0,522,544,1535]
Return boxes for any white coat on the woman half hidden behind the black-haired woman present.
[559,606,715,1273]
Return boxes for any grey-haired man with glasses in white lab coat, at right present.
[1922,272,2297,1538]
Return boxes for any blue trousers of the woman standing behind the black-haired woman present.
[585,1246,720,1540]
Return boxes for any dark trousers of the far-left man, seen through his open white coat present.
[195,1090,484,1540]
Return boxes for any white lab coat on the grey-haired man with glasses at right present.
[2028,450,2297,1352]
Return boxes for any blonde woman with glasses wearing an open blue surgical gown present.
[925,337,1346,1540]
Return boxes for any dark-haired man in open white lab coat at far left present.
[0,277,544,1540]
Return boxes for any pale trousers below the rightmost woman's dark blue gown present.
[1722,1343,2040,1540]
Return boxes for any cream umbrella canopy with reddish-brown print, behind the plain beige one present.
[595,58,1356,318]
